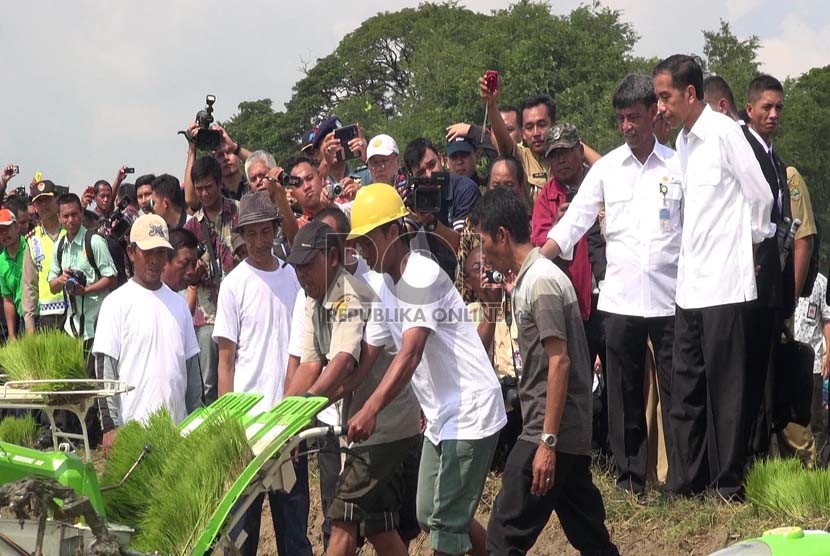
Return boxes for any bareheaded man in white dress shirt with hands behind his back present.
[653,54,775,497]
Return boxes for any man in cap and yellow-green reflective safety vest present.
[22,180,69,333]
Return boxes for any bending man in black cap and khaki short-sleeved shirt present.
[288,220,420,556]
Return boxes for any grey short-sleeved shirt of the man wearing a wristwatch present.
[513,249,593,455]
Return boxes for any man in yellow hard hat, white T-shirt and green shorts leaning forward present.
[349,183,507,554]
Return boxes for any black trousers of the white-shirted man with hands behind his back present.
[666,303,747,496]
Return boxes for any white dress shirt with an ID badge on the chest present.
[548,140,682,317]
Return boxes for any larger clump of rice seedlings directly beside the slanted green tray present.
[133,416,253,554]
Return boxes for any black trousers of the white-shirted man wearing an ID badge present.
[605,313,674,493]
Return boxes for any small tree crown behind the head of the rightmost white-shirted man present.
[703,20,760,106]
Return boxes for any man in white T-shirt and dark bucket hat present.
[213,191,311,556]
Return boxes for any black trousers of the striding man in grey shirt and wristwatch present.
[487,439,619,556]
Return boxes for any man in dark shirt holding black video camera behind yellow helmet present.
[396,138,481,278]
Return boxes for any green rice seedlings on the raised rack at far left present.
[0,330,88,389]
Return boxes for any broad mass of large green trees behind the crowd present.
[225,0,652,160]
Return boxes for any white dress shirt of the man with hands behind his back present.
[677,106,775,309]
